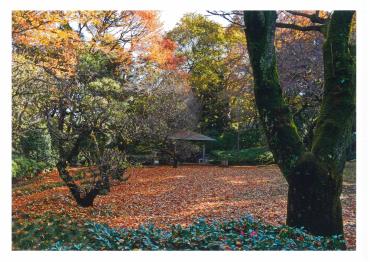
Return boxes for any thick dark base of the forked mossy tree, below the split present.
[287,153,343,236]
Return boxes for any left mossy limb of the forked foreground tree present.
[244,11,304,181]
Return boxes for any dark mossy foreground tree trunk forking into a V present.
[244,11,355,241]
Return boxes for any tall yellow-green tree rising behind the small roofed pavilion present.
[168,13,229,133]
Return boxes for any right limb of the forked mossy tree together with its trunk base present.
[287,11,356,239]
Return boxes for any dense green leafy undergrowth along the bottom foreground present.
[12,213,344,250]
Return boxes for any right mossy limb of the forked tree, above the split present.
[312,11,356,174]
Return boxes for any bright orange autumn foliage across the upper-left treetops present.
[12,11,179,78]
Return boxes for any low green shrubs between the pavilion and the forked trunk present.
[212,147,274,165]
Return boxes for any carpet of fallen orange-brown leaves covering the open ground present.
[12,165,356,250]
